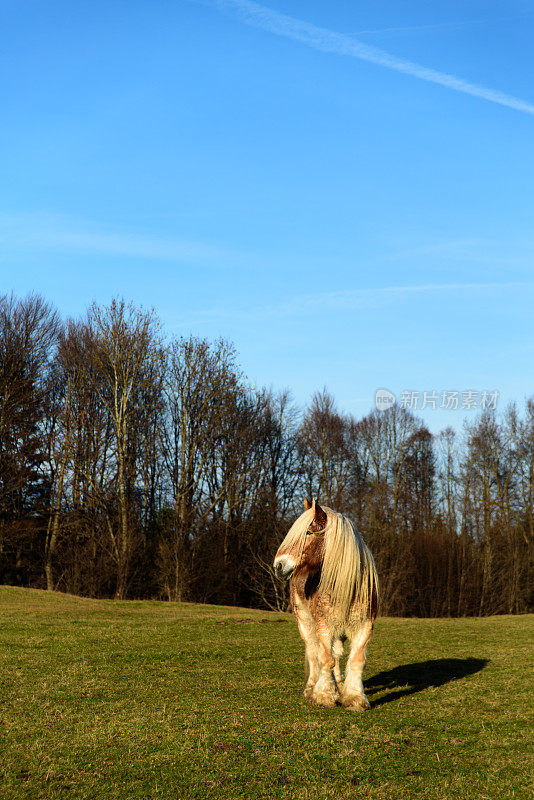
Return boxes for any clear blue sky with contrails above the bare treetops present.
[0,0,534,431]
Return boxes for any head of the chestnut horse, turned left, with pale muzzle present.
[274,500,328,580]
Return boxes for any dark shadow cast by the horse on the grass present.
[365,658,489,707]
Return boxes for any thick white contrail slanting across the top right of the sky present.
[201,0,534,114]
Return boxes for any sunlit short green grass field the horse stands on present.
[0,588,534,800]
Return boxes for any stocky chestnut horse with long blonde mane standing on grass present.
[274,500,379,711]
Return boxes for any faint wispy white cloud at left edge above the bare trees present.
[0,213,228,261]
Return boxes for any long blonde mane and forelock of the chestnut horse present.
[280,506,378,618]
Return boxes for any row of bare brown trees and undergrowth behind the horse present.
[0,295,534,616]
